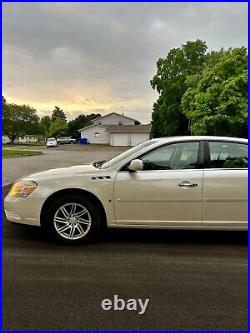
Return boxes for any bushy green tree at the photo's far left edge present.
[2,98,40,143]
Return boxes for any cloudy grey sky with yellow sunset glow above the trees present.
[3,2,247,122]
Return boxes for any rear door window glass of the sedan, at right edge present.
[209,141,248,168]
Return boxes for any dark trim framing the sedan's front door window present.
[118,139,205,172]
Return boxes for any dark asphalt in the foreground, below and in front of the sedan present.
[3,184,247,330]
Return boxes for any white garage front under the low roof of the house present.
[110,133,149,146]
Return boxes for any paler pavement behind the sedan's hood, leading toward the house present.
[2,145,127,186]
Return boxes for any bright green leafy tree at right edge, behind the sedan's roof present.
[182,47,248,137]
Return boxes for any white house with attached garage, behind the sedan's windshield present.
[79,112,151,146]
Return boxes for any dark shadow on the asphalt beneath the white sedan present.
[5,222,248,246]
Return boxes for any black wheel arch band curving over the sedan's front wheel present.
[40,188,107,227]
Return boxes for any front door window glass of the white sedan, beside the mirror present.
[141,142,199,170]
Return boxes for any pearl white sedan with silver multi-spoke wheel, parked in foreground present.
[5,136,248,243]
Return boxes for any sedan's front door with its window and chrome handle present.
[114,141,203,227]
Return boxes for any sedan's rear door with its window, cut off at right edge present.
[203,141,248,229]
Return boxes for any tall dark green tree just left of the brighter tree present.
[151,39,207,137]
